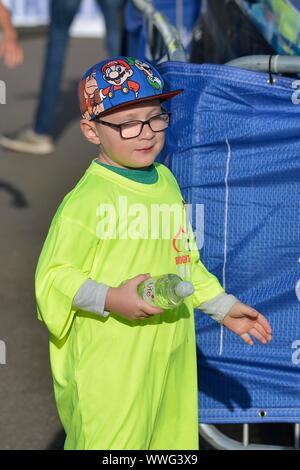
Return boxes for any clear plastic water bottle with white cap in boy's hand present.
[137,274,195,309]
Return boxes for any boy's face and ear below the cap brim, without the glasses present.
[81,100,165,168]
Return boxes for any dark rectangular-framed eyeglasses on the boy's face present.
[95,112,171,139]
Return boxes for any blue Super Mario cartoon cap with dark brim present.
[79,57,183,121]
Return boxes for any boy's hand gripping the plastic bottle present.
[104,274,163,320]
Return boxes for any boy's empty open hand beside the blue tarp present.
[222,302,272,346]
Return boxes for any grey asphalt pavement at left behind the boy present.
[0,37,106,449]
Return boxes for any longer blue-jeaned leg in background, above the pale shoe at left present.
[34,0,81,135]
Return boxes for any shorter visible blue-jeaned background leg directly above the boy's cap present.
[97,0,123,57]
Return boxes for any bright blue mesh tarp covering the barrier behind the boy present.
[161,62,300,423]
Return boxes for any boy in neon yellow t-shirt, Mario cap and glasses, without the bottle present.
[36,57,271,450]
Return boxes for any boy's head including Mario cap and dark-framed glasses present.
[79,57,182,168]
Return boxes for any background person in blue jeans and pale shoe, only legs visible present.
[0,0,123,155]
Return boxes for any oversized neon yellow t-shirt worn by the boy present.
[36,161,223,450]
